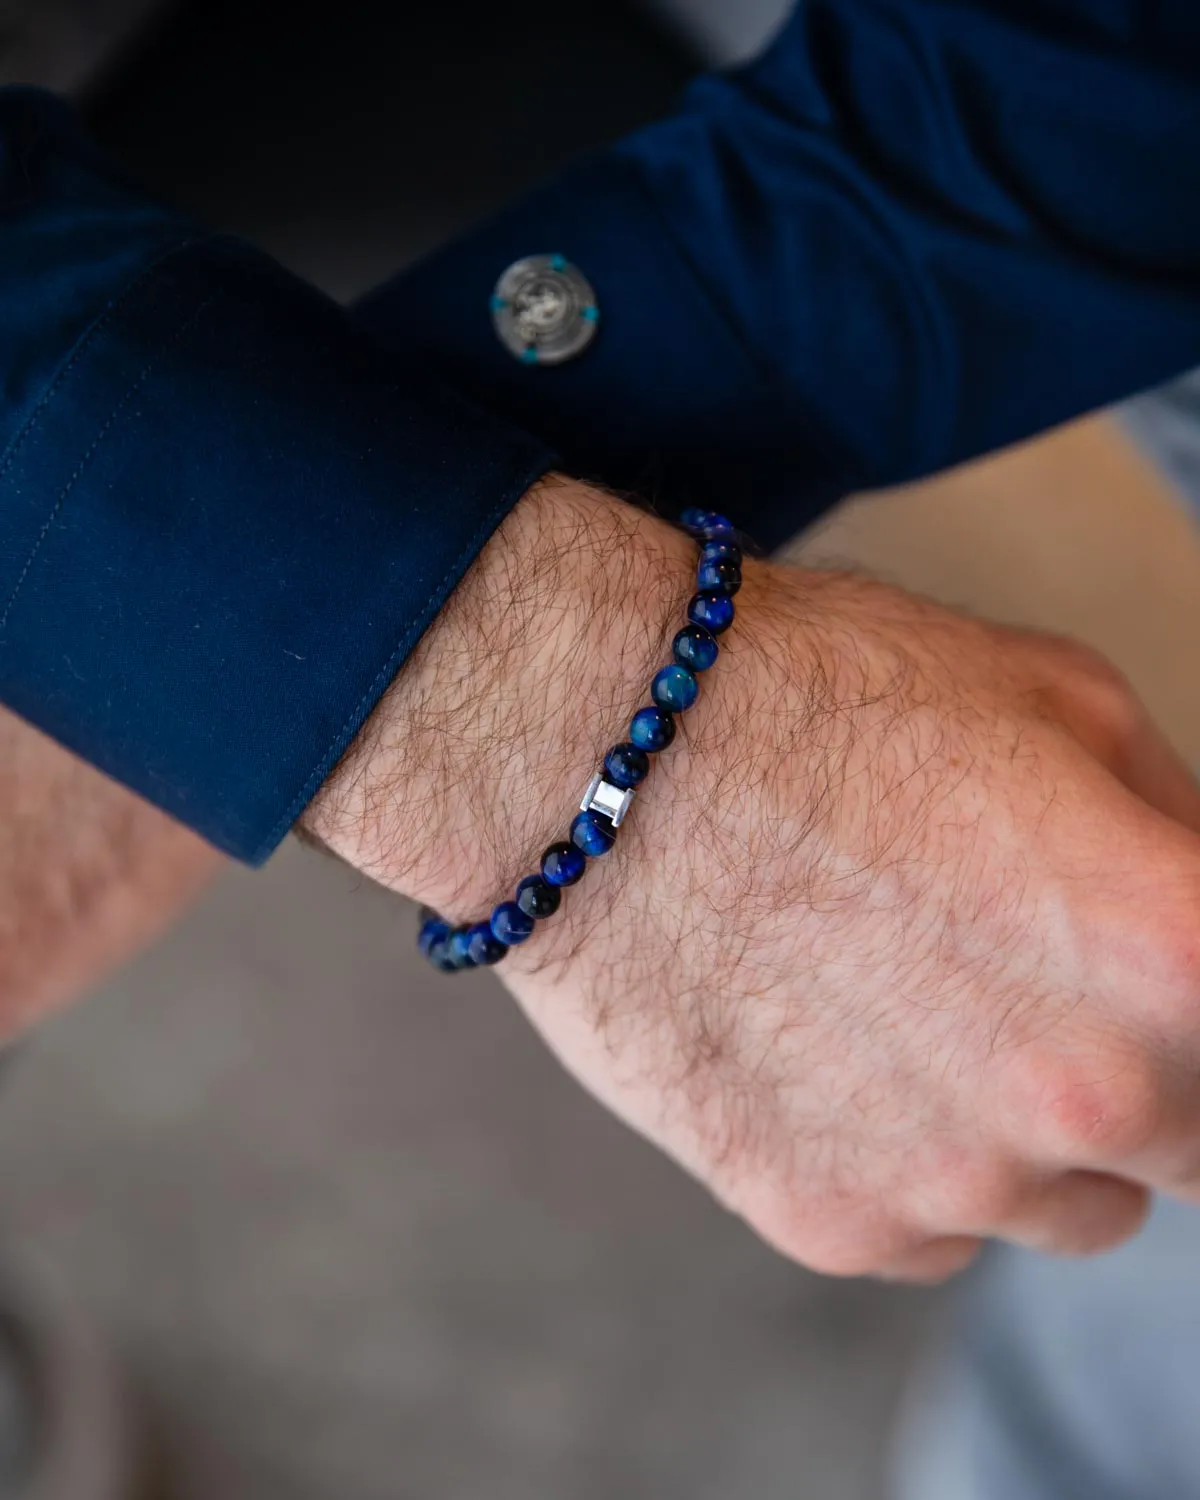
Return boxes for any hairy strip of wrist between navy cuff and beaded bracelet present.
[300,476,695,918]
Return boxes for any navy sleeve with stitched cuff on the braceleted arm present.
[0,90,552,863]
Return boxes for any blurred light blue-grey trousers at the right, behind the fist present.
[891,372,1200,1500]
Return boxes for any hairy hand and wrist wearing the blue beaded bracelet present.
[305,480,1200,1278]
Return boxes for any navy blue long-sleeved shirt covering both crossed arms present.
[0,0,1200,863]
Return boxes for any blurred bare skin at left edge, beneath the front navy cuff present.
[0,708,224,1043]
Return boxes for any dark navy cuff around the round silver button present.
[357,150,854,546]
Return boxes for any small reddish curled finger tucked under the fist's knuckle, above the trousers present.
[989,1172,1151,1256]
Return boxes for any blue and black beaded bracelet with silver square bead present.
[417,509,741,974]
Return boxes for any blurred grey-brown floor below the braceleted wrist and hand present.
[0,848,929,1500]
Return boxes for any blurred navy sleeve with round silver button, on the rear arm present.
[362,0,1200,545]
